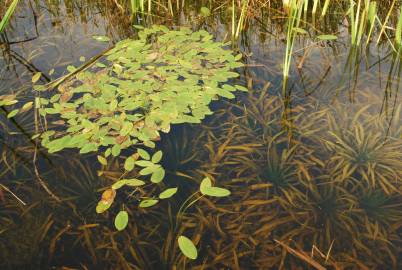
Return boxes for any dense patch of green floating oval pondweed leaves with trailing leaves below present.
[32,26,246,229]
